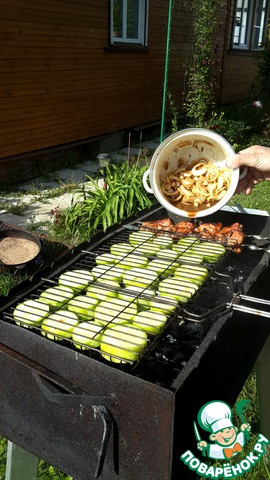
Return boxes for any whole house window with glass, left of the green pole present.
[111,0,148,45]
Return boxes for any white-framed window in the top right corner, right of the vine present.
[232,0,269,50]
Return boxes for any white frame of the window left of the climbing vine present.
[110,0,149,46]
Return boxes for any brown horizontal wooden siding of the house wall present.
[0,0,264,176]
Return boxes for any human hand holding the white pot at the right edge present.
[227,145,270,195]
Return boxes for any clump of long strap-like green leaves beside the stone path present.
[60,156,154,240]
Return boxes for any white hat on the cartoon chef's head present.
[198,401,233,433]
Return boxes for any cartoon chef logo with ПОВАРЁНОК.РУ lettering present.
[180,400,270,479]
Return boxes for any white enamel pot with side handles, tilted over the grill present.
[143,128,246,218]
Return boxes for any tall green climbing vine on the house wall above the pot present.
[184,0,219,127]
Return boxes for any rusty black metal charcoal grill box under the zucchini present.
[0,206,270,480]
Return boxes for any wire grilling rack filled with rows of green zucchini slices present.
[4,224,233,366]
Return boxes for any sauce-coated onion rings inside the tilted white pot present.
[161,157,231,209]
